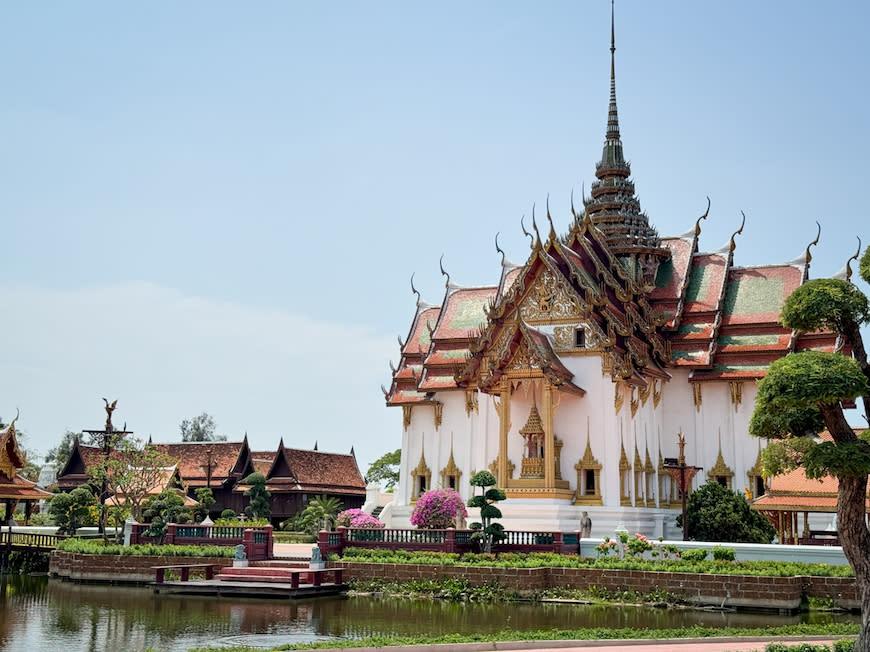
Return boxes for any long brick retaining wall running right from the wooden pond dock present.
[330,562,860,611]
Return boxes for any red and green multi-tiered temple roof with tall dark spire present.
[384,7,835,408]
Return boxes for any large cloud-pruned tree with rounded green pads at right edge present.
[749,268,870,652]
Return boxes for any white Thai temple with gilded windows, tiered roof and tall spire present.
[382,7,835,538]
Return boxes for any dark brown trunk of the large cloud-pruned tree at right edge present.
[821,405,870,652]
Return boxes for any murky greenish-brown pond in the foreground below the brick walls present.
[0,575,860,652]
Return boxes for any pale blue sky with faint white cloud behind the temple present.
[0,0,870,471]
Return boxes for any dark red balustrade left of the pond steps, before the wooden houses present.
[130,523,274,561]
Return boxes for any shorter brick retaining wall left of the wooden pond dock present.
[48,550,233,584]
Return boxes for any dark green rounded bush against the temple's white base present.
[677,480,776,543]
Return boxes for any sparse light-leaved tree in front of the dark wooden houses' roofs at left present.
[88,439,177,529]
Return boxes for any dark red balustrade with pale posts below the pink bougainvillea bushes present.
[317,527,580,559]
